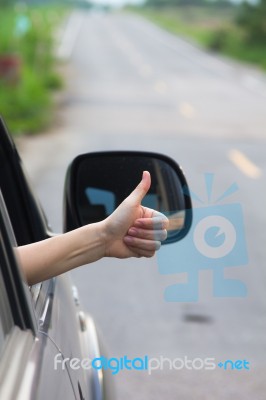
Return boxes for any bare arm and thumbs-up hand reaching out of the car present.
[17,171,168,285]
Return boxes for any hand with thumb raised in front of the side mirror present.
[104,171,168,258]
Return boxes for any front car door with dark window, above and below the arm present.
[0,119,88,399]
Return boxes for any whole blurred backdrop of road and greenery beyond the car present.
[0,0,266,400]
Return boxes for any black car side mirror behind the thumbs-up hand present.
[64,152,192,243]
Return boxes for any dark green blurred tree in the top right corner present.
[237,0,266,44]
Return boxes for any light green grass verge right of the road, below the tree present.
[129,6,266,70]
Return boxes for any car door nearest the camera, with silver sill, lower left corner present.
[0,193,78,400]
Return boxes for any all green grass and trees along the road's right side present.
[131,0,266,69]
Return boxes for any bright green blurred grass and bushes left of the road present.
[0,6,66,135]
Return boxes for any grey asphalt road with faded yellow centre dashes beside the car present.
[16,13,266,400]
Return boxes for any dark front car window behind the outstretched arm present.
[0,118,52,305]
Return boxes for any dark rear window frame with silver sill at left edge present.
[0,197,37,400]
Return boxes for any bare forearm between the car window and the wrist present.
[17,222,105,285]
